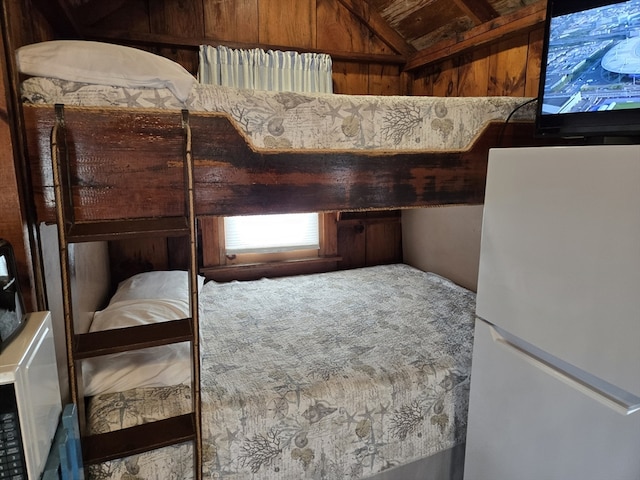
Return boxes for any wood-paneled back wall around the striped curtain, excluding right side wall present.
[91,0,407,95]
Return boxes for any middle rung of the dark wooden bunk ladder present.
[74,318,194,360]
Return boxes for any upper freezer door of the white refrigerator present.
[472,145,640,400]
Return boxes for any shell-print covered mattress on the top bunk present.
[22,77,535,152]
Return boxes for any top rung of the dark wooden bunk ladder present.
[67,217,189,242]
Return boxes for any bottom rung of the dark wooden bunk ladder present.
[82,413,195,465]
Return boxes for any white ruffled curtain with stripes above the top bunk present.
[198,45,333,93]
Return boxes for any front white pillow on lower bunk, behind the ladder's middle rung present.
[82,300,191,396]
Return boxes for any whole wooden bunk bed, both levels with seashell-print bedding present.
[18,42,535,480]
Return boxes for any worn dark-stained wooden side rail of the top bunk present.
[24,105,552,222]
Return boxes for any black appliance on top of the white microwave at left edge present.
[0,239,26,352]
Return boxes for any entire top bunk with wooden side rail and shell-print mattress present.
[18,42,536,222]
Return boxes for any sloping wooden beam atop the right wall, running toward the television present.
[404,0,547,72]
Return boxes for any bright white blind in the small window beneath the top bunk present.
[224,213,320,255]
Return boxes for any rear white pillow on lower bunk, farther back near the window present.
[109,270,204,305]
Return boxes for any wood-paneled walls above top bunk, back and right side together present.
[89,0,543,97]
